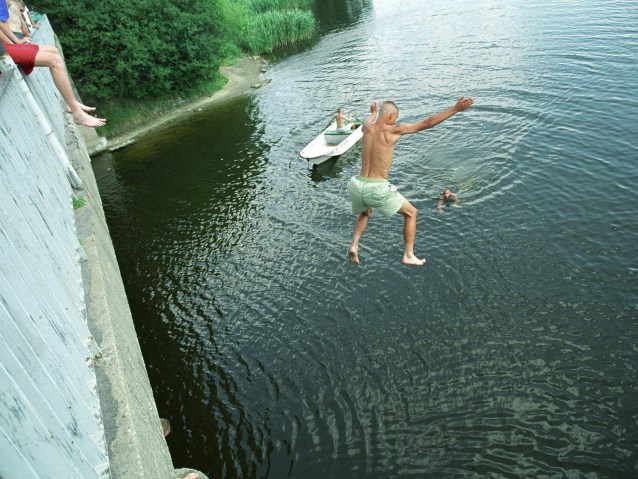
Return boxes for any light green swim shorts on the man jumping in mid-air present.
[348,176,405,216]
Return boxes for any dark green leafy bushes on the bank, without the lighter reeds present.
[38,0,224,99]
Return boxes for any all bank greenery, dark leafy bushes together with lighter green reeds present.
[38,0,316,104]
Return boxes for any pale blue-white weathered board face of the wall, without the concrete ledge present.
[0,57,110,479]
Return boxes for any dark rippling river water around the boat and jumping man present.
[94,0,638,479]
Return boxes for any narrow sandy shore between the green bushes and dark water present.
[105,56,268,151]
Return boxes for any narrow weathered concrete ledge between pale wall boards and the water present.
[66,117,175,478]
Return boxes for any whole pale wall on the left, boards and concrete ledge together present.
[0,18,175,479]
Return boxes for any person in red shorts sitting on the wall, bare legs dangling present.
[0,0,106,128]
